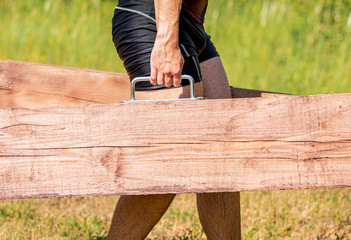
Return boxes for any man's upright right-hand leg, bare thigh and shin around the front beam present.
[197,57,241,240]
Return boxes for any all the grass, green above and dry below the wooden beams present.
[0,0,351,240]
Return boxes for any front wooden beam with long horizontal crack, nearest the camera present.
[0,94,351,199]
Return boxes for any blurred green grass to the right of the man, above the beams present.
[206,0,351,94]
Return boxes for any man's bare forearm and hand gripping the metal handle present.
[150,0,184,87]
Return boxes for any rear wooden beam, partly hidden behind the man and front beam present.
[0,60,286,108]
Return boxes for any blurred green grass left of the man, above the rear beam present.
[0,0,124,72]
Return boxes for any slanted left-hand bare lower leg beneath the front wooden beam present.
[107,194,175,240]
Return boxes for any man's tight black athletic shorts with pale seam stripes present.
[112,0,219,90]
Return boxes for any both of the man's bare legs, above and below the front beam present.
[107,58,240,240]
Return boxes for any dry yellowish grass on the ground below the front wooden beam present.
[0,189,351,240]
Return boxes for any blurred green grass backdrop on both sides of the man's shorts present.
[0,0,351,94]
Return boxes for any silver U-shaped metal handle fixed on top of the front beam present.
[122,75,205,103]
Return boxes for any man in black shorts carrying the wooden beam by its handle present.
[108,0,240,240]
